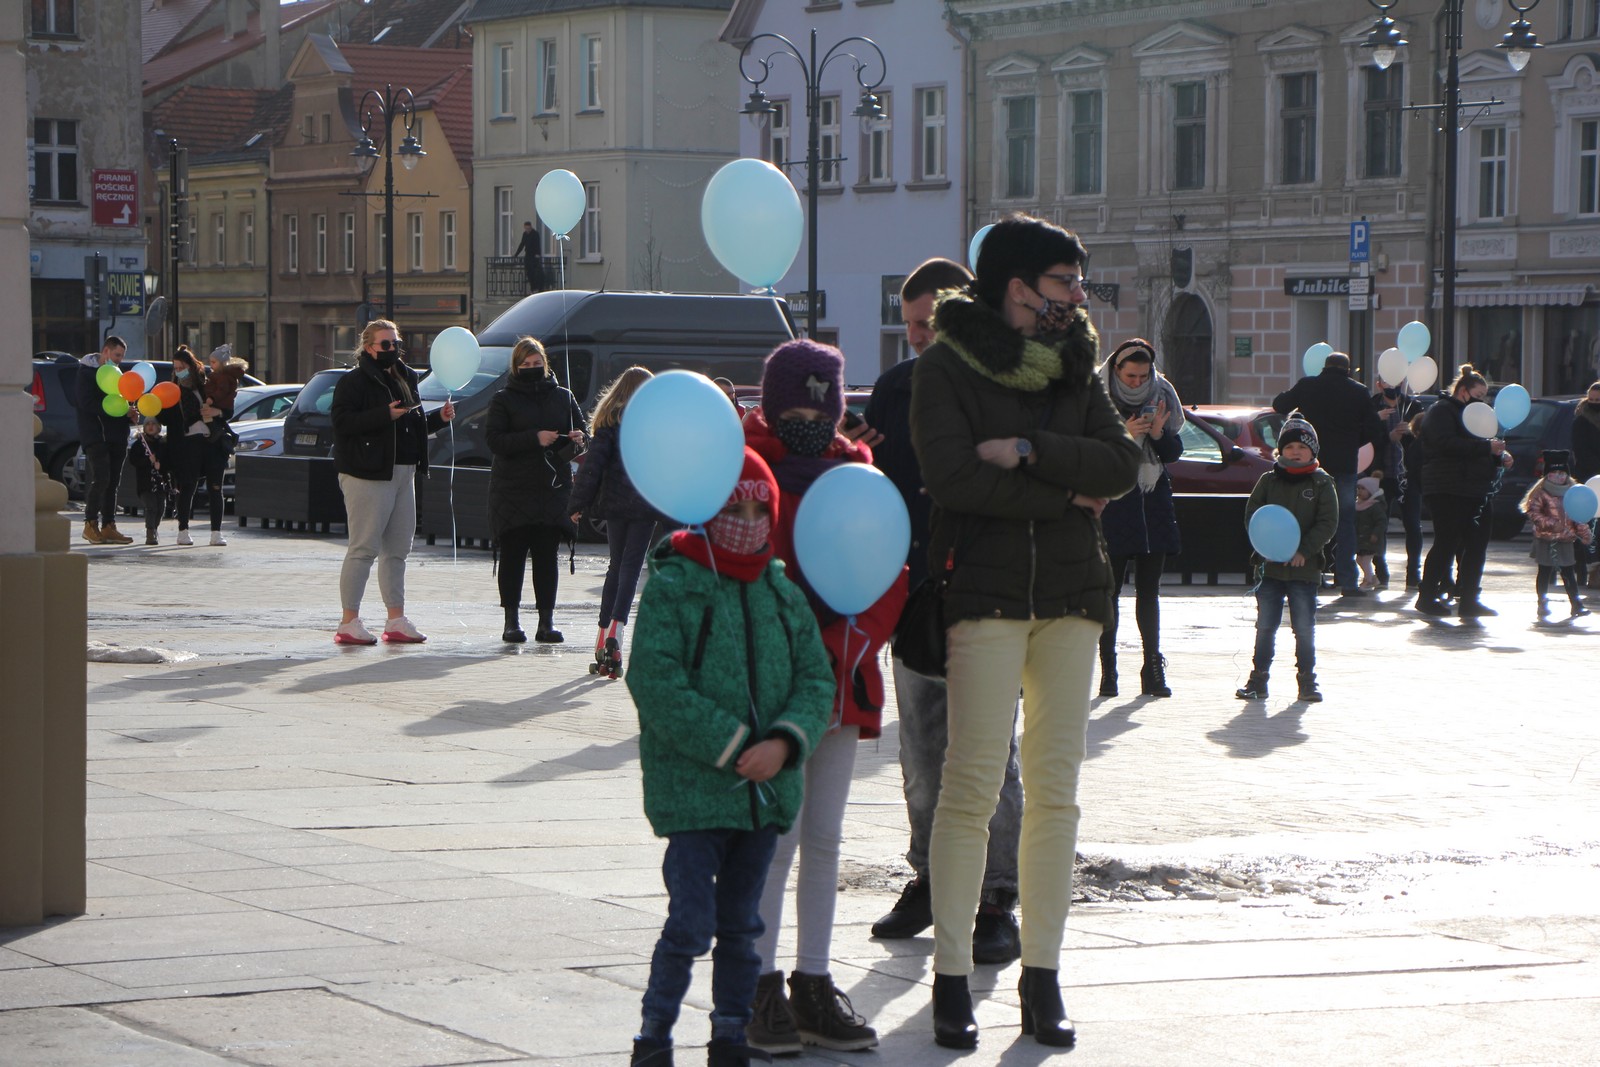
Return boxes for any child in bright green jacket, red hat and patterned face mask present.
[626,448,834,1067]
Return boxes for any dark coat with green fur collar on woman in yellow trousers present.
[910,296,1139,624]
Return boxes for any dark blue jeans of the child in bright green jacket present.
[640,827,778,1045]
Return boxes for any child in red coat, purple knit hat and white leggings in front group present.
[744,341,907,1053]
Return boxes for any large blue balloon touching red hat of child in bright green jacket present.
[621,371,744,525]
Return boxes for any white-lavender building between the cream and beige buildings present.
[723,0,970,384]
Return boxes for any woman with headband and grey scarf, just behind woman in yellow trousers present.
[1099,338,1184,696]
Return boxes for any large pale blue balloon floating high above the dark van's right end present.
[701,158,805,290]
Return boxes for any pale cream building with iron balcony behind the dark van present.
[464,0,739,325]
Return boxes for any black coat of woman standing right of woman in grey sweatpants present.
[486,374,586,537]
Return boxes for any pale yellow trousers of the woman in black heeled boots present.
[928,617,1101,974]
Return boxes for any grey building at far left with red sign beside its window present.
[24,0,146,357]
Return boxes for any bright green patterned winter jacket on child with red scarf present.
[627,544,834,837]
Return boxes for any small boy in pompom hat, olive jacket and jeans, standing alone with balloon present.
[1234,411,1339,704]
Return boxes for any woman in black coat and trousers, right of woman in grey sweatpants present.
[488,338,584,645]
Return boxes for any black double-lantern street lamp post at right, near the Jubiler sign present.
[1362,0,1542,374]
